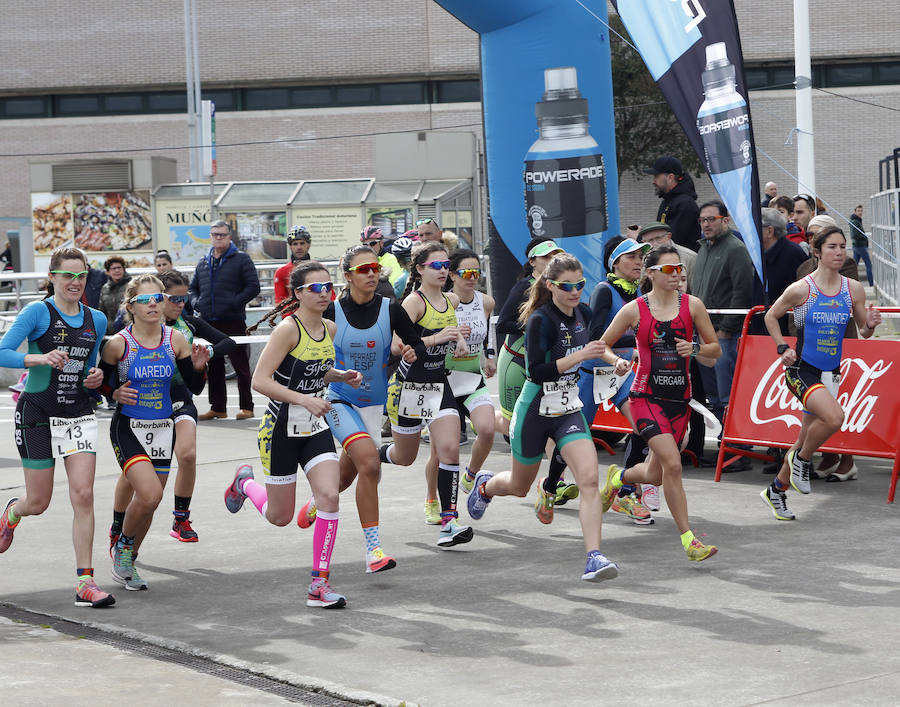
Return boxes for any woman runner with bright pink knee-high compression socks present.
[225,260,362,609]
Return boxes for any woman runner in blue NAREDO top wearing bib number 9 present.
[102,275,209,591]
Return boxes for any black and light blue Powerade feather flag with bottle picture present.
[613,0,765,282]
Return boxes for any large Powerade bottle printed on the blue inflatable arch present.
[524,66,607,239]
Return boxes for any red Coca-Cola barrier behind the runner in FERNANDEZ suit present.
[716,307,900,503]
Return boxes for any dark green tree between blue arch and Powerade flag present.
[609,14,706,180]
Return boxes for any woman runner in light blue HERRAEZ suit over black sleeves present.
[297,245,425,573]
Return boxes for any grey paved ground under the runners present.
[0,384,900,707]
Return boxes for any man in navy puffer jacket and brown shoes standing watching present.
[190,221,260,420]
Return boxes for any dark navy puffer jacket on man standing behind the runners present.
[190,243,260,322]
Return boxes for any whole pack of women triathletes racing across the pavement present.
[0,221,880,608]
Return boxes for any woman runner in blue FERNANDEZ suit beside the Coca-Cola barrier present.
[760,226,881,520]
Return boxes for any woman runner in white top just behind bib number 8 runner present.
[425,249,497,499]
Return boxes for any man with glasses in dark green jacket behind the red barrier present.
[688,201,755,471]
